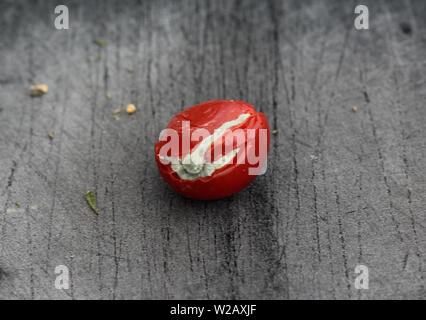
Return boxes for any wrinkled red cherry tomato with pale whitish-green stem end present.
[155,100,269,200]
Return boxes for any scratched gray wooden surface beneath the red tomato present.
[0,0,426,299]
